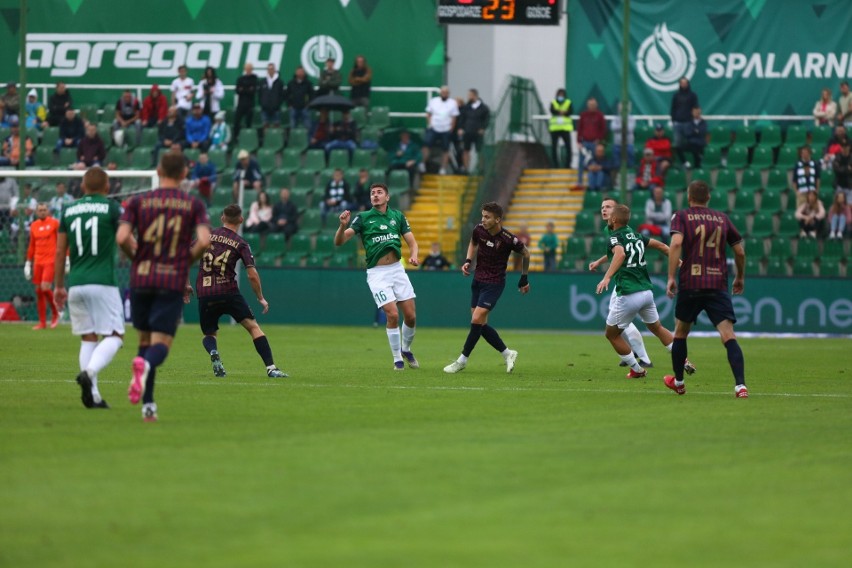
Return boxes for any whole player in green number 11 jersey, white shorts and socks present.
[54,167,124,408]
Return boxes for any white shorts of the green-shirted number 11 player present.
[68,284,124,335]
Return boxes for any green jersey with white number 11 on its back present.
[59,195,121,288]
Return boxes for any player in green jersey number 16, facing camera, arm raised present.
[334,183,420,371]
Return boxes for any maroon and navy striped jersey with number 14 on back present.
[671,207,743,290]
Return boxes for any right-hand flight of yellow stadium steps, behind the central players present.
[504,169,583,271]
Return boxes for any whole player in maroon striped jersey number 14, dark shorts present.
[663,181,748,398]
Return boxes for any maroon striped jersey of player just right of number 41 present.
[195,227,254,298]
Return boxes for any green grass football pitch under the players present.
[0,320,852,568]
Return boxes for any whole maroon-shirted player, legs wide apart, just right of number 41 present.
[183,205,287,378]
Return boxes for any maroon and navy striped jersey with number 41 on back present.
[121,188,210,291]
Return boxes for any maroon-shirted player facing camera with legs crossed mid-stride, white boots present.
[444,201,530,373]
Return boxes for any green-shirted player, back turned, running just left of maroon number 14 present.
[597,205,696,379]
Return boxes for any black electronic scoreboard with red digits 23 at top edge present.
[438,0,559,26]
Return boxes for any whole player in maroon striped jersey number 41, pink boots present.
[116,153,210,422]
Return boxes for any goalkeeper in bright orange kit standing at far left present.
[24,203,67,329]
